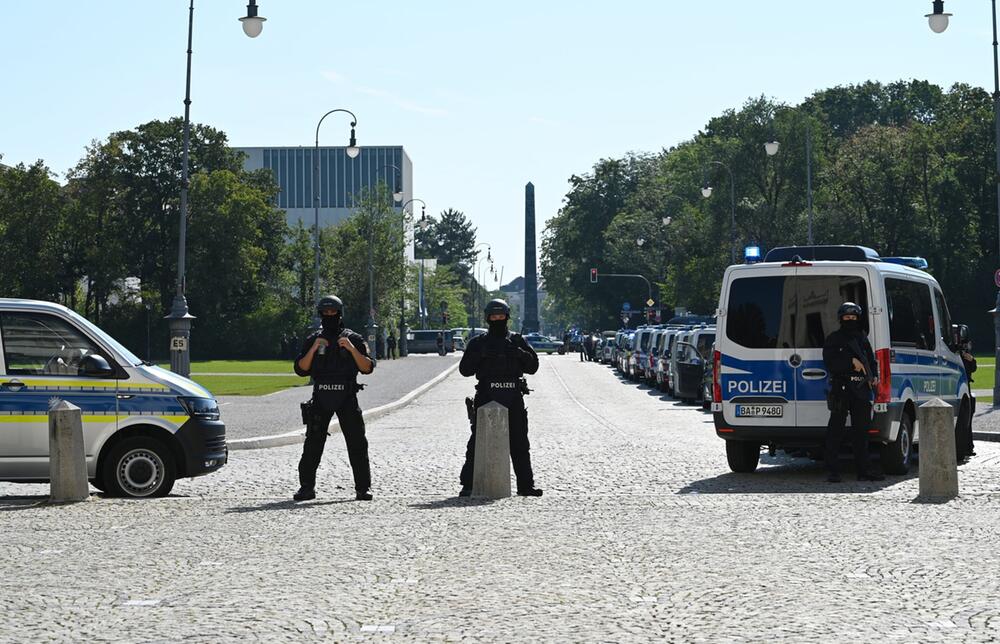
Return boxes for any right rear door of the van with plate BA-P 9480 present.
[792,263,876,427]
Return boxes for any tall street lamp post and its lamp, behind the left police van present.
[167,0,265,378]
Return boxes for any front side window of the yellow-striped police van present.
[0,313,100,376]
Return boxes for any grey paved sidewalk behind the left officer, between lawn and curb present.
[219,354,461,439]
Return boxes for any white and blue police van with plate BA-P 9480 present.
[712,246,975,474]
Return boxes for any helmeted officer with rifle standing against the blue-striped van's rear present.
[823,302,885,483]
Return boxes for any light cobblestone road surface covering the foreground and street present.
[0,356,1000,642]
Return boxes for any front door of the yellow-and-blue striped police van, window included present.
[0,311,118,479]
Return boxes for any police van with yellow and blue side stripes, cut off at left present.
[0,299,228,497]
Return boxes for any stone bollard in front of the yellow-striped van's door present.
[49,400,90,503]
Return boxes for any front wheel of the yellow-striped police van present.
[101,436,177,498]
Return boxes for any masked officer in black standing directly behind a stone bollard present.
[458,300,542,496]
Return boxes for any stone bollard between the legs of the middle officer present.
[472,401,510,499]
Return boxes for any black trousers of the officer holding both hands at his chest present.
[299,392,372,492]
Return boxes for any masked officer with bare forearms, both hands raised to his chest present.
[292,295,375,501]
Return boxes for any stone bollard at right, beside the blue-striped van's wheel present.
[919,398,958,500]
